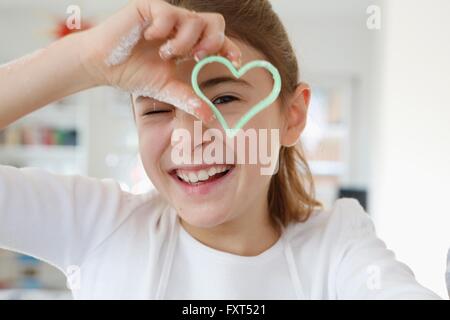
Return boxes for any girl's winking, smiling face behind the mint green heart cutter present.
[133,41,292,228]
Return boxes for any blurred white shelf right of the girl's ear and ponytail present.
[301,74,364,208]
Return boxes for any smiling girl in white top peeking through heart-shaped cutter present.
[0,0,438,299]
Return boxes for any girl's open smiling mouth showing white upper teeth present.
[170,165,235,186]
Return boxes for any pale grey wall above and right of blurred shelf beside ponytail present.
[272,0,378,187]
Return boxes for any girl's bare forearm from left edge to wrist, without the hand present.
[0,34,96,129]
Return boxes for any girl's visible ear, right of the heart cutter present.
[281,83,311,147]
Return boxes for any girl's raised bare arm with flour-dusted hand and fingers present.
[0,0,241,129]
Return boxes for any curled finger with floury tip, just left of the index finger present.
[160,13,206,60]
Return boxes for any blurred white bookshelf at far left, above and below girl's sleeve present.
[0,94,88,300]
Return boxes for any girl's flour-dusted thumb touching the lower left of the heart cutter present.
[159,80,215,123]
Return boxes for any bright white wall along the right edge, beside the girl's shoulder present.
[371,0,450,297]
